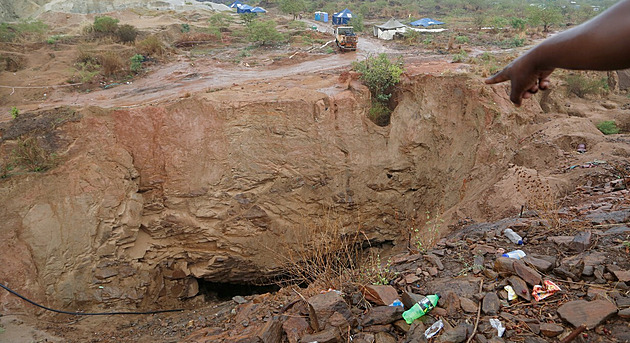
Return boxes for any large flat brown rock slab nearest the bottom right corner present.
[558,300,617,330]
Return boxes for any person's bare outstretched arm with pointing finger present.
[486,0,630,106]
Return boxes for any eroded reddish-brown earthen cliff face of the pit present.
[0,76,544,306]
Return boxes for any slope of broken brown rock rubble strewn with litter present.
[187,181,630,343]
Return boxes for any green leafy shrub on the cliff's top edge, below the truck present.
[352,54,404,102]
